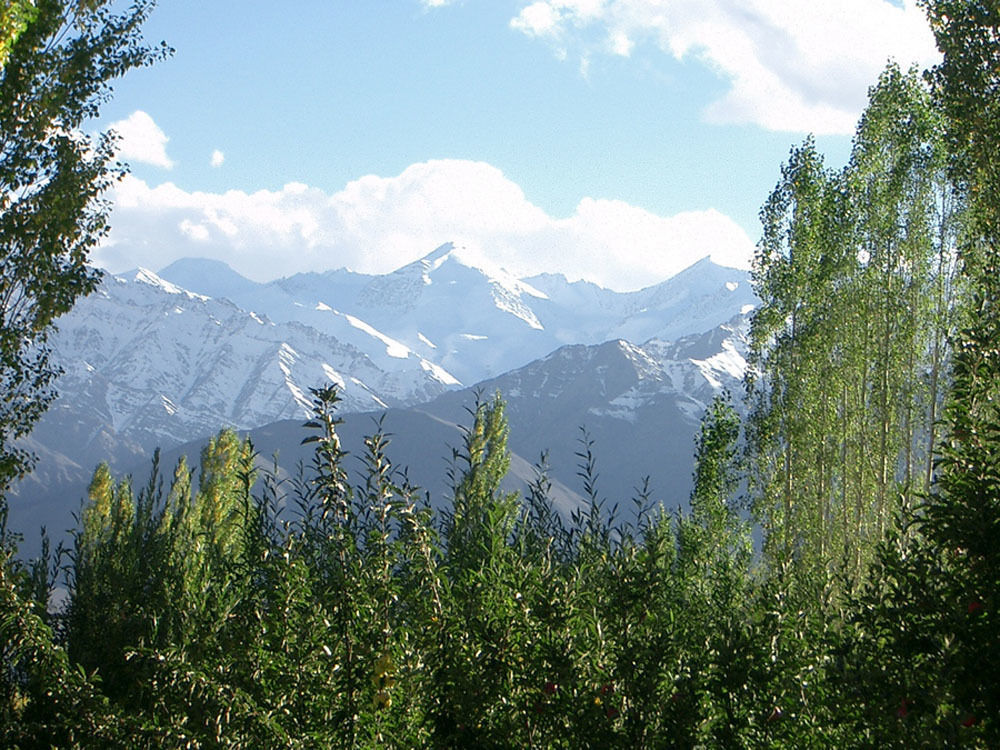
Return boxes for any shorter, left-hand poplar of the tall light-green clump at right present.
[747,139,848,580]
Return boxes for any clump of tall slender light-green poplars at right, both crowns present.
[747,65,961,581]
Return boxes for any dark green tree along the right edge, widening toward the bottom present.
[843,5,1000,747]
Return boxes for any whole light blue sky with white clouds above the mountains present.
[92,0,938,290]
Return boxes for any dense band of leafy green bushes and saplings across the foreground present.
[0,376,997,748]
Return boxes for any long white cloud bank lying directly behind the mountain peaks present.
[94,160,753,289]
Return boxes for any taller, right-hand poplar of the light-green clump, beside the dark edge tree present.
[847,64,960,541]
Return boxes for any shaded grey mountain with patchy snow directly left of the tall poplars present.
[412,315,749,507]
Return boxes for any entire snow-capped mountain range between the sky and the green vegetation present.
[11,243,756,556]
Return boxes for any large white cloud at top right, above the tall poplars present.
[510,0,938,134]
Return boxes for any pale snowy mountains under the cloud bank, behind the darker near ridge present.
[25,243,754,482]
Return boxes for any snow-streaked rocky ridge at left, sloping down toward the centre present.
[42,269,454,470]
